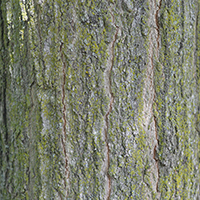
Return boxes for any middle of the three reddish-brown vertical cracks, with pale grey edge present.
[104,8,119,200]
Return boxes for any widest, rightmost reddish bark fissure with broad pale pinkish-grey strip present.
[144,0,162,199]
